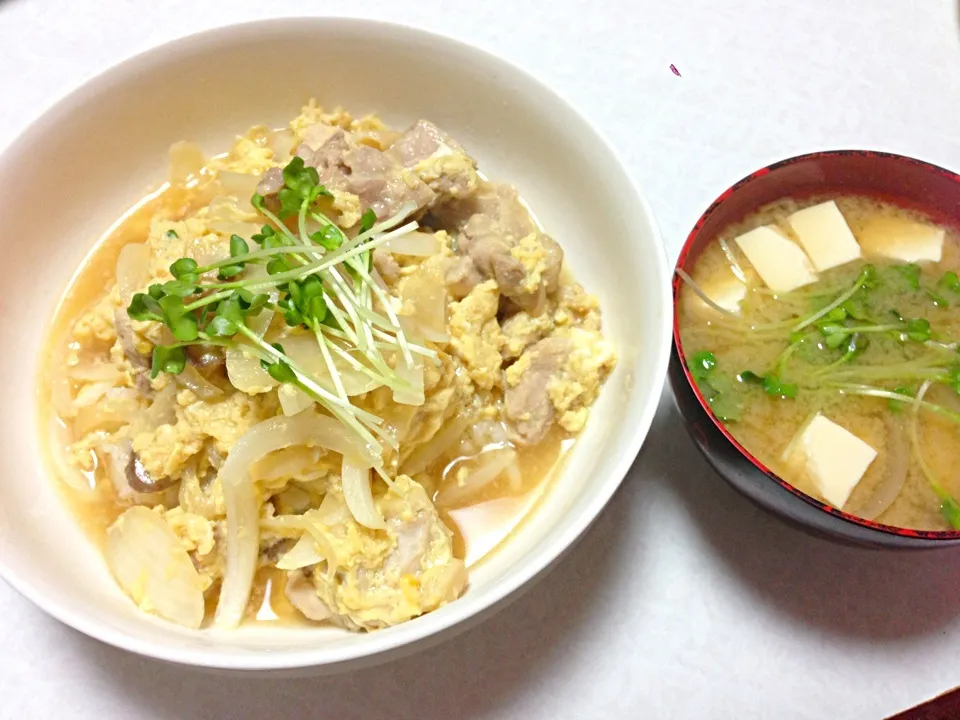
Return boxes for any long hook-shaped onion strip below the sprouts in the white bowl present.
[215,412,376,628]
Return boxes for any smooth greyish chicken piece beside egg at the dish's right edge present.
[503,336,571,445]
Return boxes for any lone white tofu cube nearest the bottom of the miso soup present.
[788,413,877,509]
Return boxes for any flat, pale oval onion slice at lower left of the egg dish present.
[105,506,204,628]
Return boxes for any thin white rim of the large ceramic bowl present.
[0,15,672,672]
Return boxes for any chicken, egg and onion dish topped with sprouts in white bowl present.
[41,103,615,630]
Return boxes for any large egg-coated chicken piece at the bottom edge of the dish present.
[287,475,466,630]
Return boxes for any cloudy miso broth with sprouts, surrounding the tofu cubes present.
[678,195,960,530]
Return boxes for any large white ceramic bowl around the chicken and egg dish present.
[0,18,670,671]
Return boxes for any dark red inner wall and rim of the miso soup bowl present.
[673,150,960,541]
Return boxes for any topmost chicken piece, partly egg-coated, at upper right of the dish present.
[387,120,480,205]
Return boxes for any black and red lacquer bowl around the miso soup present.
[669,150,960,548]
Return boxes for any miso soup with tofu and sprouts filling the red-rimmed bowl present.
[678,196,960,530]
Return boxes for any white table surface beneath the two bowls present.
[0,0,960,720]
